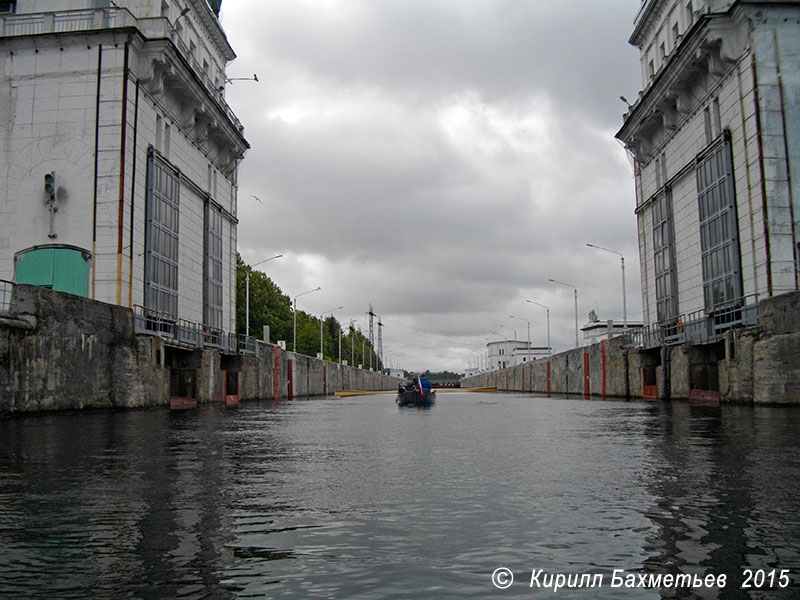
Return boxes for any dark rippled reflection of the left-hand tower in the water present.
[0,411,244,598]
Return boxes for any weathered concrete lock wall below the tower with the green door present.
[0,284,400,413]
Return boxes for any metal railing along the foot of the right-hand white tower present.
[625,295,758,349]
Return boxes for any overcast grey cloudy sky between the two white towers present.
[221,0,642,372]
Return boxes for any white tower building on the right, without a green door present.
[617,0,800,341]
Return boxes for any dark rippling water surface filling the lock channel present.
[0,392,800,600]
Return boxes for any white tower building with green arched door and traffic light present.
[0,0,248,332]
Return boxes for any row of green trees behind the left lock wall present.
[236,252,383,371]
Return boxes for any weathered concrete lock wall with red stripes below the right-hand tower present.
[461,292,800,404]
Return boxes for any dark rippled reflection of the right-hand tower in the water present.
[643,404,800,598]
